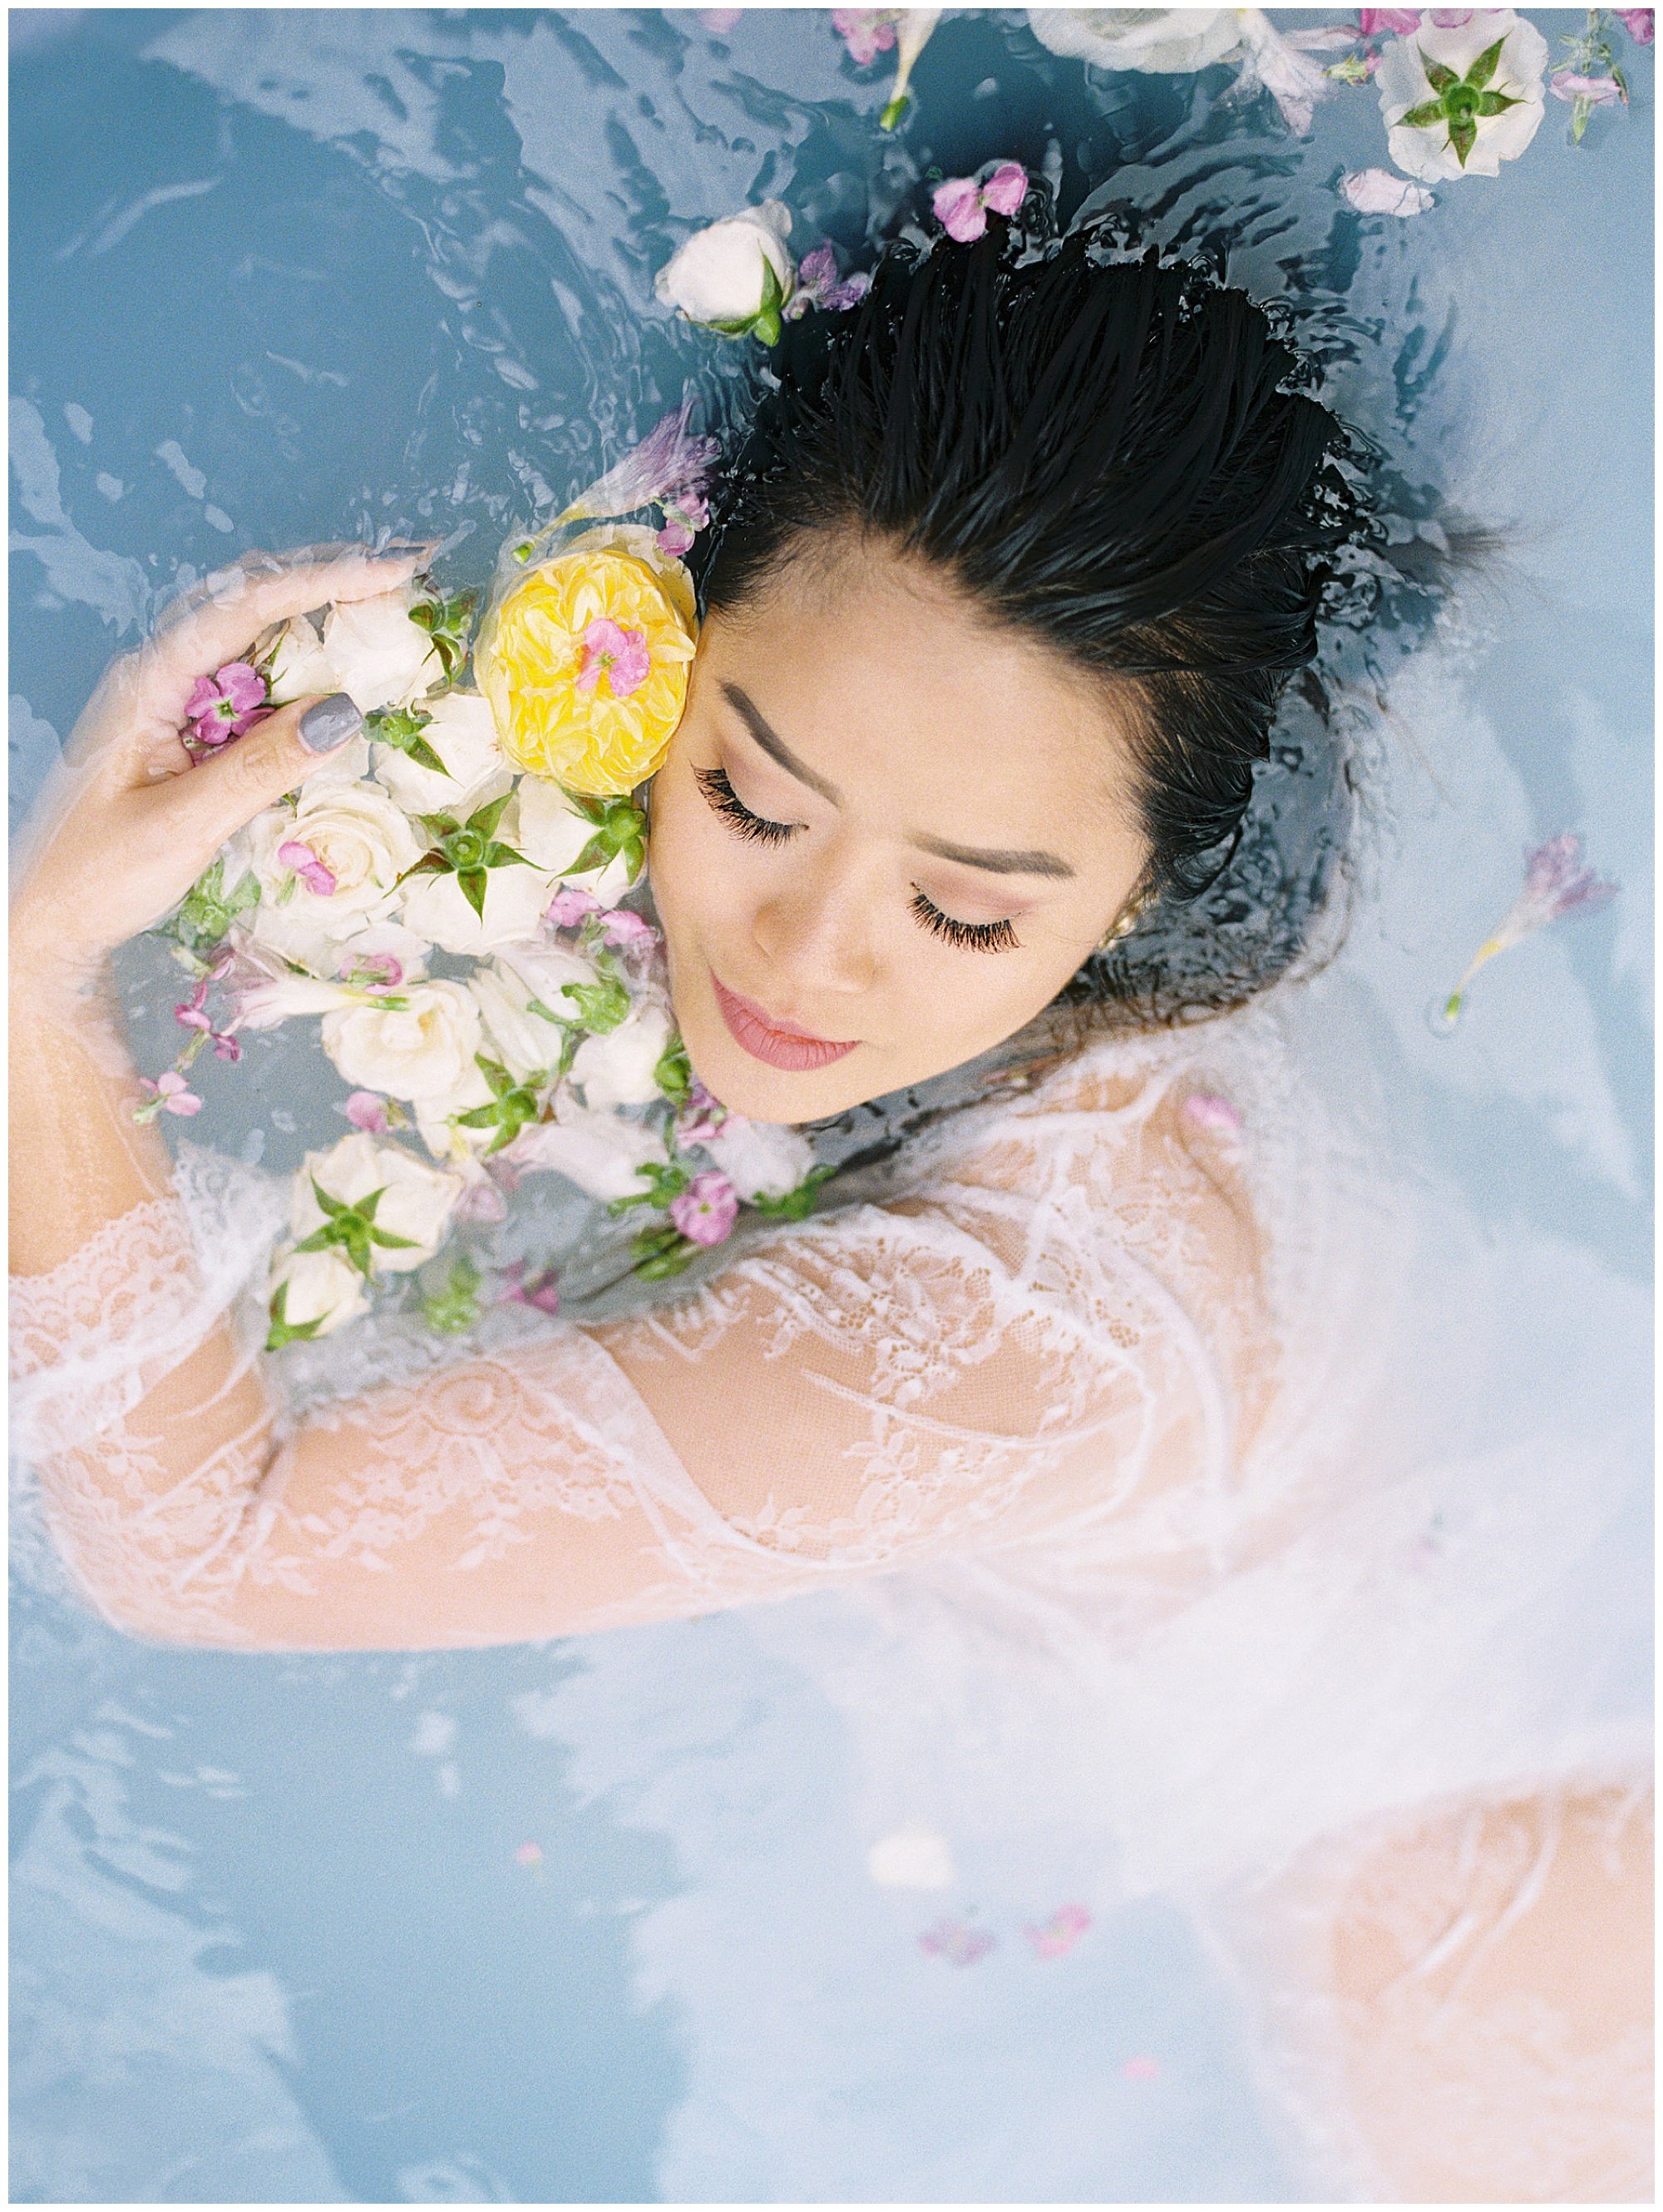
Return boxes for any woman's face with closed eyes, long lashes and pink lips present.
[653,544,1147,1122]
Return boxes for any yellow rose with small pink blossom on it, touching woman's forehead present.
[473,526,698,798]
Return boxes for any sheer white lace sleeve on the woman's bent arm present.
[6,1158,1205,1648]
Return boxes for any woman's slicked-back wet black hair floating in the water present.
[692,213,1371,1020]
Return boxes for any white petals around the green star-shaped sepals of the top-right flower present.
[1374,9,1548,184]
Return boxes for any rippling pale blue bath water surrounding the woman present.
[11,11,1652,2203]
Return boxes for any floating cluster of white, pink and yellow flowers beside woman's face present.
[137,407,827,1350]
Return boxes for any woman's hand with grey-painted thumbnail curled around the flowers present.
[11,546,425,980]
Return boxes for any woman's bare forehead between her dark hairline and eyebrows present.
[701,544,1133,856]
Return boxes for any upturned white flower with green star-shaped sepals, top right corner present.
[1375,9,1548,184]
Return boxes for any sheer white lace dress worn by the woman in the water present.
[11,1006,1650,2201]
